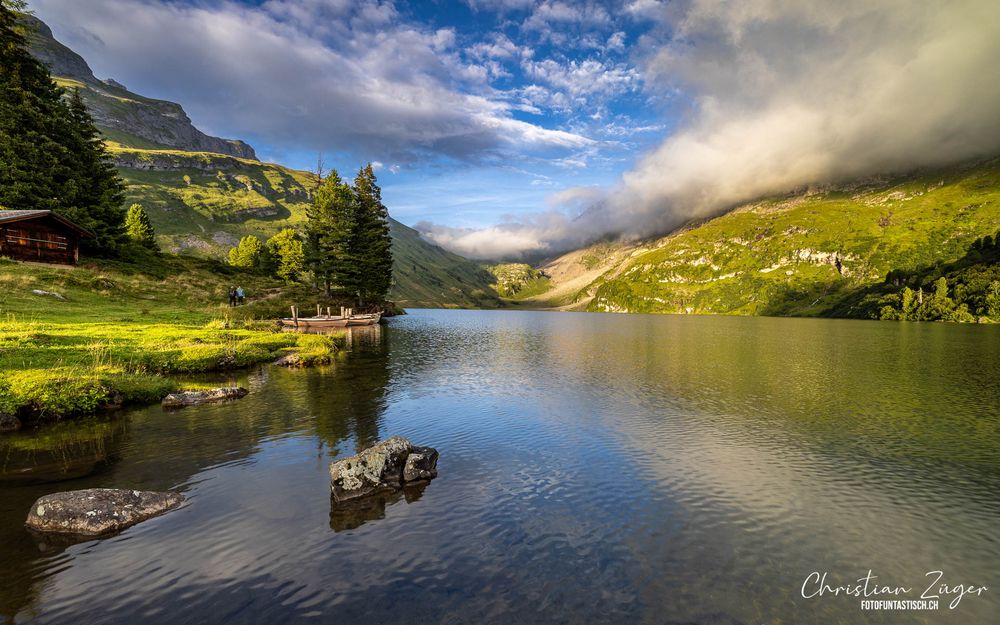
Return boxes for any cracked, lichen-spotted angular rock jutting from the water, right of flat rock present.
[330,436,438,501]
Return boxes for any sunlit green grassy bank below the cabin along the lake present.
[0,256,342,419]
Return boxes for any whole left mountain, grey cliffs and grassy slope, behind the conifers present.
[25,16,500,308]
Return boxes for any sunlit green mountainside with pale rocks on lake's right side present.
[527,158,1000,316]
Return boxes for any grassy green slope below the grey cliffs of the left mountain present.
[108,141,499,308]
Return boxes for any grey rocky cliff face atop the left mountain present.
[25,16,257,160]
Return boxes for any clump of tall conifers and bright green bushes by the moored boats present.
[229,163,392,305]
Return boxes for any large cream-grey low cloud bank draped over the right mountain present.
[424,0,1000,257]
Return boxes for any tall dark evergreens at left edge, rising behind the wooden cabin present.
[0,0,124,254]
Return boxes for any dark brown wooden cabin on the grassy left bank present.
[0,209,94,265]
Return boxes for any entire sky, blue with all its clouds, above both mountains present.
[30,0,1000,258]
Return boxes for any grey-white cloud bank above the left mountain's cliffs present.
[31,0,596,163]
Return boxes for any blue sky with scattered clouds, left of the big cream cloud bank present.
[32,0,670,252]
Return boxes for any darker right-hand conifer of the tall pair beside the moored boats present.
[350,163,392,304]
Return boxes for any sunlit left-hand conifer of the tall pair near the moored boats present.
[305,170,355,295]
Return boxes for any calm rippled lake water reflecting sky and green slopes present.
[0,310,1000,625]
